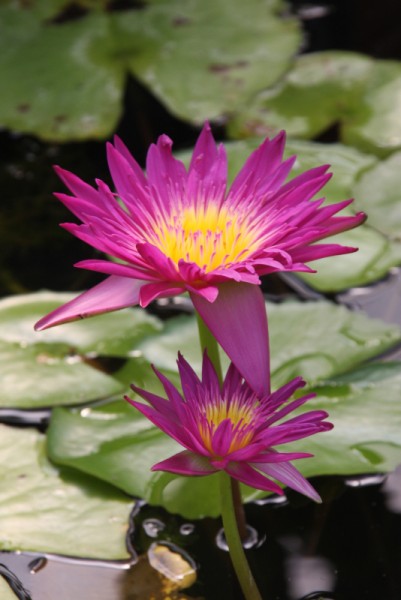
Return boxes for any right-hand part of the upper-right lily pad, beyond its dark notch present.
[342,60,401,156]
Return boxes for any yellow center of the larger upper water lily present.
[149,203,254,272]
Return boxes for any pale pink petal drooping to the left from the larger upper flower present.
[35,275,146,331]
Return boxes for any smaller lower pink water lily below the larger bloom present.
[126,353,332,502]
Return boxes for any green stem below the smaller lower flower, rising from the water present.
[219,471,262,600]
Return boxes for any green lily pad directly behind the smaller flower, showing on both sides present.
[48,363,401,518]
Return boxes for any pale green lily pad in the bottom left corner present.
[0,425,132,559]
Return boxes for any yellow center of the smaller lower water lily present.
[199,400,258,454]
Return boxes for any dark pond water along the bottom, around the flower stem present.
[0,469,401,600]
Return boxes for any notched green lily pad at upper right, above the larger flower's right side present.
[228,51,401,156]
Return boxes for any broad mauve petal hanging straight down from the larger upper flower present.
[191,283,270,396]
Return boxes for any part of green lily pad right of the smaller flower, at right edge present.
[288,363,401,477]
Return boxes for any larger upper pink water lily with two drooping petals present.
[36,124,365,393]
